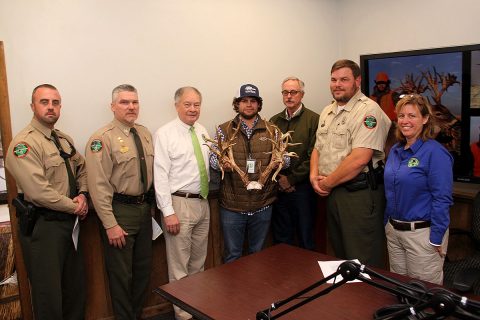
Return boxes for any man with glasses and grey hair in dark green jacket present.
[270,77,319,250]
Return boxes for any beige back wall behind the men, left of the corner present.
[0,0,339,150]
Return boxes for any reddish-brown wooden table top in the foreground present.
[156,244,404,320]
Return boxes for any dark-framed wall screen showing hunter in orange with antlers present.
[360,44,480,183]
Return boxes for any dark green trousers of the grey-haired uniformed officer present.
[101,201,152,320]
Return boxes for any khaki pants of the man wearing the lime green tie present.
[162,196,210,319]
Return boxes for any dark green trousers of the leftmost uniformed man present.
[18,213,85,320]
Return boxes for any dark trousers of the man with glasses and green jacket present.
[272,182,317,250]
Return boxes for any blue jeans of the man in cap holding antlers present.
[220,206,272,263]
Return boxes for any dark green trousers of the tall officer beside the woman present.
[327,185,385,268]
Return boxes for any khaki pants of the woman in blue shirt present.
[385,222,448,285]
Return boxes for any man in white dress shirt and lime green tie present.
[154,87,210,320]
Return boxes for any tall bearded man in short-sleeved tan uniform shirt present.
[310,60,391,267]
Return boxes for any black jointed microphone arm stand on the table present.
[256,261,480,320]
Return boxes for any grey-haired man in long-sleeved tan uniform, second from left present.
[85,85,153,319]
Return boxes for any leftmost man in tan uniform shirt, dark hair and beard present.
[5,84,88,320]
